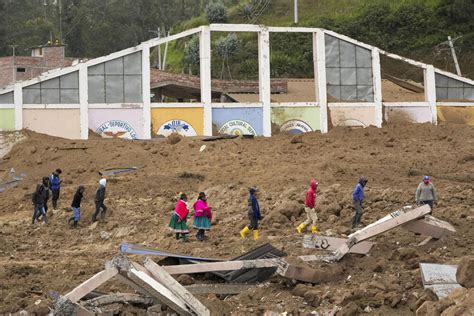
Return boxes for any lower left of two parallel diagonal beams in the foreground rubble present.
[127,268,192,315]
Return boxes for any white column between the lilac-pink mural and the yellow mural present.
[142,43,151,139]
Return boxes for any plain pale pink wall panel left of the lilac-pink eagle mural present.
[23,109,81,139]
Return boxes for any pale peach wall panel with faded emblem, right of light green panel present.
[328,105,375,127]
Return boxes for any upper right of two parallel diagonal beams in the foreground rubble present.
[144,258,211,316]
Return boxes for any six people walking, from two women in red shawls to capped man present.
[169,176,438,241]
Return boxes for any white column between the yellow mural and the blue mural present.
[199,26,212,136]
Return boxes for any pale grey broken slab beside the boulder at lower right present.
[420,262,461,299]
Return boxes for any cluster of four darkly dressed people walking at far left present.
[32,169,107,228]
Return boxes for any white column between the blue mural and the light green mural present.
[258,28,272,137]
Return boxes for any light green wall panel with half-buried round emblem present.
[272,107,320,134]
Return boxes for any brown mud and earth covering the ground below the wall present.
[0,124,474,315]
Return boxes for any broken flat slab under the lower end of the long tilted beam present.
[303,235,375,261]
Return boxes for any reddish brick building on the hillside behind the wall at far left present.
[0,45,76,87]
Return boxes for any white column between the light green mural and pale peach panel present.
[313,30,328,133]
